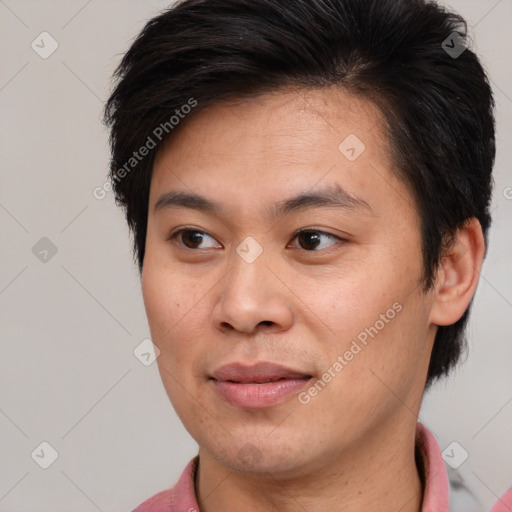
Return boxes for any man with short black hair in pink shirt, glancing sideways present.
[106,0,511,512]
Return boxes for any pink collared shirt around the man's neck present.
[133,422,512,512]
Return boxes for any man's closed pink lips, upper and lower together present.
[211,362,312,409]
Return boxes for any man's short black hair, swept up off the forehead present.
[105,0,495,388]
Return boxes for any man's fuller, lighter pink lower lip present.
[212,377,311,409]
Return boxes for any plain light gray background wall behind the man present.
[0,0,512,512]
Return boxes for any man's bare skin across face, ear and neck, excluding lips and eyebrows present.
[142,89,484,512]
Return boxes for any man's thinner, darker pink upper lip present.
[212,361,311,383]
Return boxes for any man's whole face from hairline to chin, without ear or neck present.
[142,89,435,474]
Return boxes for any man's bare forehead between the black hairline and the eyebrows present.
[150,88,414,222]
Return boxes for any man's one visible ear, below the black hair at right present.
[430,218,485,325]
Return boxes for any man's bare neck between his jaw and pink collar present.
[196,422,423,512]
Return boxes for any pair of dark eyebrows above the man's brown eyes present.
[153,183,374,218]
